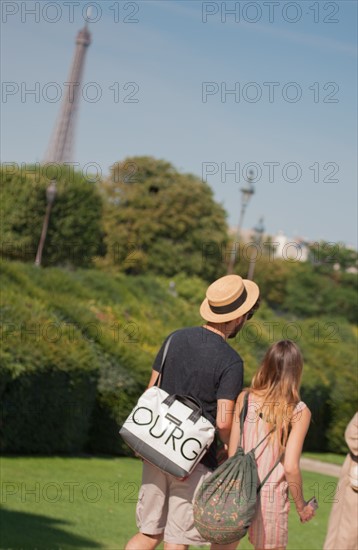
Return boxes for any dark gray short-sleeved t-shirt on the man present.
[153,327,243,469]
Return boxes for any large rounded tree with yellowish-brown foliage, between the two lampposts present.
[103,157,227,280]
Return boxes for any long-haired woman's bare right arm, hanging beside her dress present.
[283,407,314,522]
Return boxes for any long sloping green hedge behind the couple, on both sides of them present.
[0,261,357,454]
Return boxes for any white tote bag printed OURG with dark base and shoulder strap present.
[119,338,215,479]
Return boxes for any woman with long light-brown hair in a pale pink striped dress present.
[225,340,314,550]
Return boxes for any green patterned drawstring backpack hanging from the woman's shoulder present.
[194,392,281,545]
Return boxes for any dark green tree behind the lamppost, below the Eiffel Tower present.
[1,166,103,266]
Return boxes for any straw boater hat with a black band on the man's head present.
[200,275,260,323]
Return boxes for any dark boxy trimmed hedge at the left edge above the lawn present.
[0,366,97,454]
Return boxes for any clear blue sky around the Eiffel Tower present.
[1,0,357,247]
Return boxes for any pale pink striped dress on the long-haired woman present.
[243,393,306,549]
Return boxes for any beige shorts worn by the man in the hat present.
[137,462,211,546]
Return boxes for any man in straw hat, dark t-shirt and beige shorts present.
[125,275,259,550]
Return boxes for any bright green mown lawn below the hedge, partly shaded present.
[0,457,337,550]
